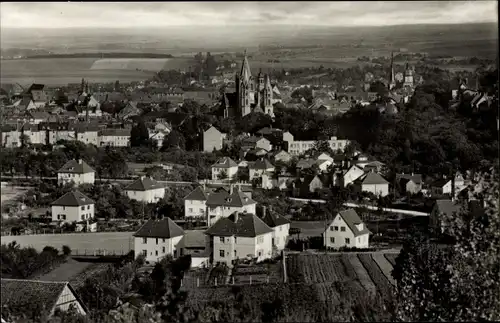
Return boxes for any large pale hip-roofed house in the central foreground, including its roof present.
[205,212,274,266]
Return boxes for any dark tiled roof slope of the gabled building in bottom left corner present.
[1,278,79,315]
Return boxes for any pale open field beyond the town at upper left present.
[0,58,192,86]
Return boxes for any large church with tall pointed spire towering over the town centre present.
[221,52,274,118]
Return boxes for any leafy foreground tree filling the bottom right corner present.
[393,170,500,322]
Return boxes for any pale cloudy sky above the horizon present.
[0,0,498,28]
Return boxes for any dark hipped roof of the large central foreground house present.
[205,213,273,238]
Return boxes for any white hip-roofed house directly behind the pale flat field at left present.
[51,190,95,223]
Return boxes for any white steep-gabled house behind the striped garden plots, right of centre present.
[323,209,370,249]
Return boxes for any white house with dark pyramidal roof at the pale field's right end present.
[134,218,184,262]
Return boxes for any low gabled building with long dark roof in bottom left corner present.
[1,278,87,318]
